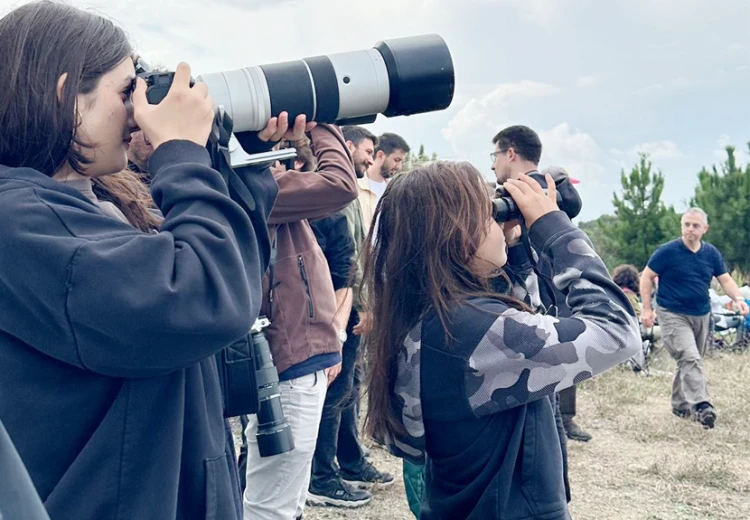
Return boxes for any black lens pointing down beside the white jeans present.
[252,331,294,457]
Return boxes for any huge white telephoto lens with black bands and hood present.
[196,34,455,132]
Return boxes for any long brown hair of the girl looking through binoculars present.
[363,161,527,439]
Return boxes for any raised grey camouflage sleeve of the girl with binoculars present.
[465,212,641,416]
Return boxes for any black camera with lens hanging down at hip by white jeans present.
[219,316,294,457]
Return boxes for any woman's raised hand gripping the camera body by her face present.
[133,63,214,150]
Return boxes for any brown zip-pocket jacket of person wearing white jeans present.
[260,125,357,374]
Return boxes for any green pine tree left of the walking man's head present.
[600,153,680,269]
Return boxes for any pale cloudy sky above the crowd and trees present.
[0,0,750,220]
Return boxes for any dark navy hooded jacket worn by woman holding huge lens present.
[0,141,277,520]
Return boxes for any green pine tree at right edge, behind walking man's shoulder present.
[690,143,750,274]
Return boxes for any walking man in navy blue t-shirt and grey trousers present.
[640,208,750,428]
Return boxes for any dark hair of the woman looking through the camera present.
[0,1,132,177]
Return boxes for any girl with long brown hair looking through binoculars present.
[365,162,640,520]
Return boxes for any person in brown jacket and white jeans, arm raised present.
[243,121,357,520]
